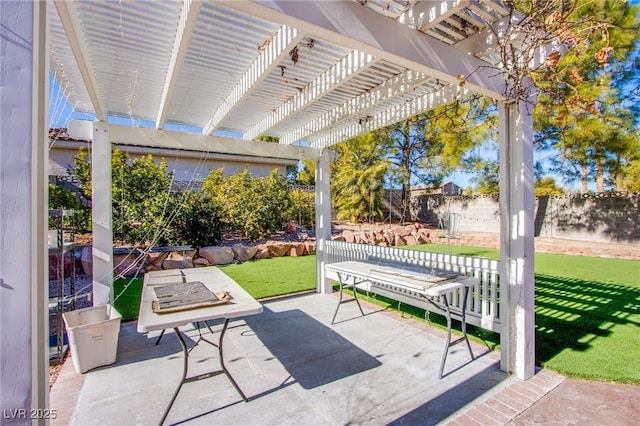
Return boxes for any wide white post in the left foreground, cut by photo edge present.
[0,0,49,424]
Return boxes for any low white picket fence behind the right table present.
[326,240,500,332]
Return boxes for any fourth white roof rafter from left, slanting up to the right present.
[243,50,376,143]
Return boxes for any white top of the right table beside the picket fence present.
[326,261,478,296]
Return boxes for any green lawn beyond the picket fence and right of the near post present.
[412,244,640,383]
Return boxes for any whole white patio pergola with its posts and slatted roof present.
[0,0,534,414]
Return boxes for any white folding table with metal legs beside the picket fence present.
[325,261,478,378]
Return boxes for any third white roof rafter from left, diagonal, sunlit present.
[202,25,305,135]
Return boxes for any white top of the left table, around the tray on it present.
[138,266,262,333]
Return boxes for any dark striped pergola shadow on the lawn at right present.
[536,274,640,364]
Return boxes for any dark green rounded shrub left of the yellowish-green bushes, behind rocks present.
[162,191,222,248]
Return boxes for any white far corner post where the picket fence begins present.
[316,150,333,294]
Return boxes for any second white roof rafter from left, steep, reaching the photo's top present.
[156,0,202,129]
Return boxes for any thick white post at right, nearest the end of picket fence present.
[500,102,535,380]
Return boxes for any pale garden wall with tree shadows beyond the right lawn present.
[412,193,640,243]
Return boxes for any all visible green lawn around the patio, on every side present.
[114,244,640,383]
